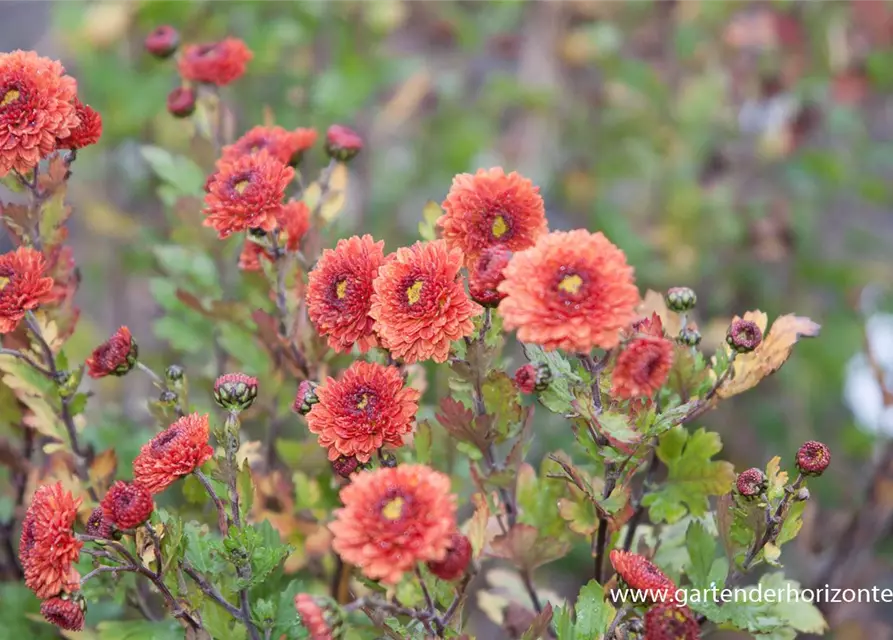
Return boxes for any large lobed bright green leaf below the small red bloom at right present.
[642,426,735,523]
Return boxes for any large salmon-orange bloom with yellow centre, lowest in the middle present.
[329,465,456,584]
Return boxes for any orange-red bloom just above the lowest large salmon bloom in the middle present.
[307,360,420,462]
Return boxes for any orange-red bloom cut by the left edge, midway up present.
[0,247,54,333]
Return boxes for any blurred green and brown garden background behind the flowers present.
[0,0,893,638]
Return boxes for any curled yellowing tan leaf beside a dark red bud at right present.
[716,311,821,398]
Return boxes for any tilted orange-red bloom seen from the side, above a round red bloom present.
[133,413,214,494]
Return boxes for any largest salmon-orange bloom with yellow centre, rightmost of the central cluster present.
[498,229,639,353]
